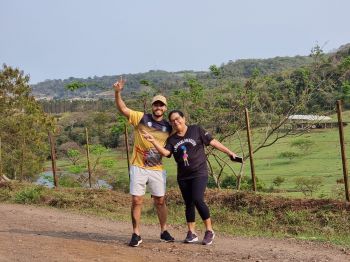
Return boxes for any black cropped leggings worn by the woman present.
[178,176,210,222]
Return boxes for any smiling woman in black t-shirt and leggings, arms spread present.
[143,110,236,245]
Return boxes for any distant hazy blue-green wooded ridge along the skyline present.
[32,56,311,99]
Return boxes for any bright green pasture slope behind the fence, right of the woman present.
[211,126,350,197]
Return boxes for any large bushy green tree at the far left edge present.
[0,65,54,180]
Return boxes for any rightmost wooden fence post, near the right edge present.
[337,100,350,202]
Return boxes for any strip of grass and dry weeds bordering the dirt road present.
[0,182,350,247]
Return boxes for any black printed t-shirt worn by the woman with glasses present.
[165,125,213,180]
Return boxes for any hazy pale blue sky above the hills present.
[0,0,350,84]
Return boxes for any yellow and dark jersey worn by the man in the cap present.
[129,110,171,170]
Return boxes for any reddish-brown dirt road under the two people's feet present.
[0,204,350,262]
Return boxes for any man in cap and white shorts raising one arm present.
[113,78,174,247]
